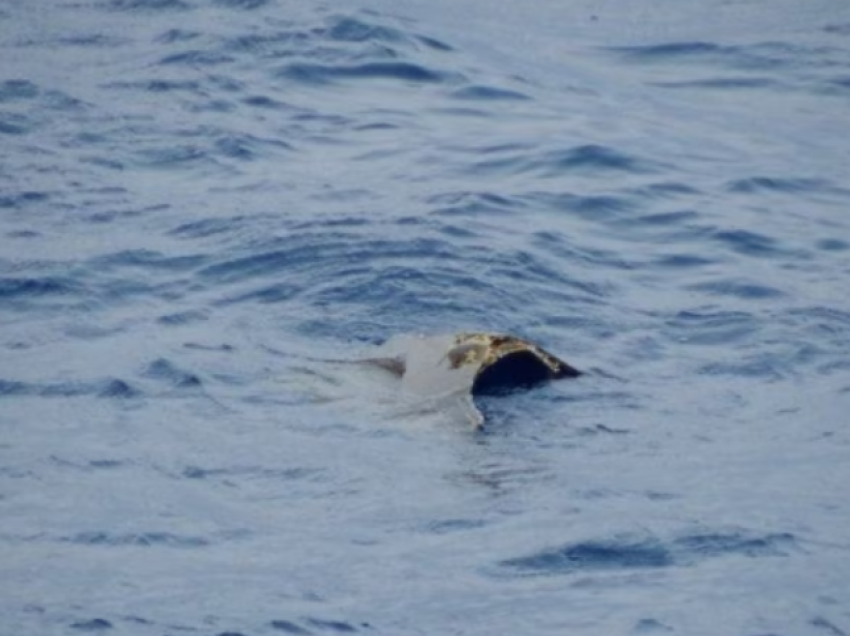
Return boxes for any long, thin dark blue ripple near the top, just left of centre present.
[275,62,458,85]
